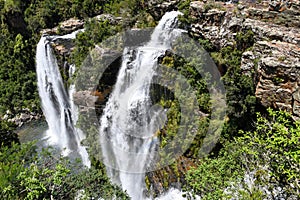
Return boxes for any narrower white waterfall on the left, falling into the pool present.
[36,31,90,166]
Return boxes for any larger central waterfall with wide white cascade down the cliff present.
[100,11,180,200]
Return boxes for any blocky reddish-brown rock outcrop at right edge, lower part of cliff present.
[254,40,300,114]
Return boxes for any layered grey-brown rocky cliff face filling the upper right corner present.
[189,1,300,117]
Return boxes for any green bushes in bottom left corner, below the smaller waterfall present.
[0,143,128,200]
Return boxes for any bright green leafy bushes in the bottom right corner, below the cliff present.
[186,109,300,199]
